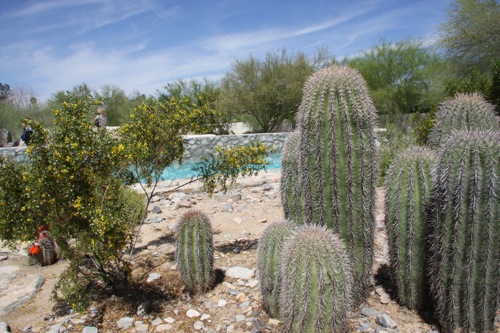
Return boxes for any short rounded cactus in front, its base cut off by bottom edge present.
[280,225,352,333]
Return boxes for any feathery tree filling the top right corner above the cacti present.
[439,0,500,76]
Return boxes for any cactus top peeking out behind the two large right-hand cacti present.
[429,93,500,149]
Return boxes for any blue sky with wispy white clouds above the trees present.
[0,0,452,100]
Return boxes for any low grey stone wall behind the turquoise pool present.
[0,132,289,162]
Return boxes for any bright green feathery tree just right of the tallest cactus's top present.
[343,40,444,114]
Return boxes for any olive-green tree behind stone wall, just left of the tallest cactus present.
[218,50,314,132]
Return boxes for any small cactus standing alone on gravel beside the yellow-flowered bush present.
[176,210,214,293]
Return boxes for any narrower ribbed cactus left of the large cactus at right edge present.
[385,147,436,309]
